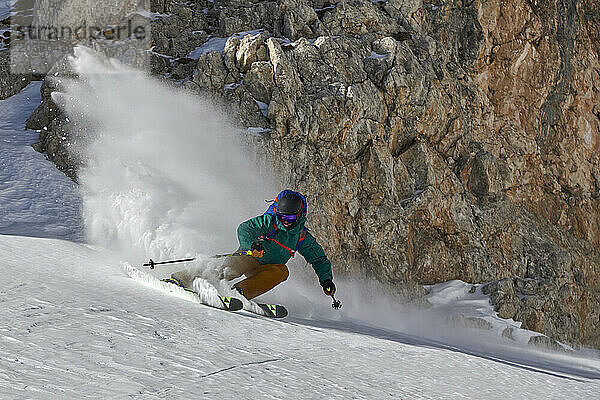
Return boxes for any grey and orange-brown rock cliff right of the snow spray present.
[29,0,600,347]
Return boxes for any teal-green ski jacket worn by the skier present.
[238,214,333,283]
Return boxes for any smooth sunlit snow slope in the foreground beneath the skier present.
[0,236,600,399]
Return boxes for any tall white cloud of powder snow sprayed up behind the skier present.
[52,47,272,262]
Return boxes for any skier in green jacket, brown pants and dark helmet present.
[166,190,336,300]
